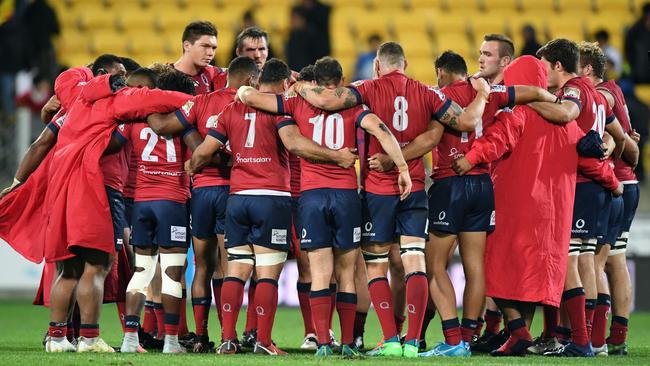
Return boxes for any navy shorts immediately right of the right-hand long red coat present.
[571,182,611,239]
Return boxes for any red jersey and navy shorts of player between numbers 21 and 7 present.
[176,88,237,238]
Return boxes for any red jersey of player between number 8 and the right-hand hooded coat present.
[432,80,515,179]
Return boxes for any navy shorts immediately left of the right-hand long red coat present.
[429,174,495,234]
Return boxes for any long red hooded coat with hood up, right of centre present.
[466,56,618,306]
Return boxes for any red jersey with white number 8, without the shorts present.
[351,71,451,195]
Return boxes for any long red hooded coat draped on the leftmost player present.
[0,75,191,262]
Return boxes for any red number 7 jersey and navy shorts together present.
[208,102,296,251]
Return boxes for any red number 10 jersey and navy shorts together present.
[278,94,370,250]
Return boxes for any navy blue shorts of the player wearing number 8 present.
[361,191,428,243]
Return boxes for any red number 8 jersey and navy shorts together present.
[351,71,452,242]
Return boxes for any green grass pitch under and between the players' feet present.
[0,301,650,366]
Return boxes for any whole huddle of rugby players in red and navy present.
[0,17,639,358]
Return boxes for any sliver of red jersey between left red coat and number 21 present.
[99,124,131,193]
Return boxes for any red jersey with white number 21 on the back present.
[130,122,190,203]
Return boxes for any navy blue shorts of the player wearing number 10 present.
[298,188,361,250]
